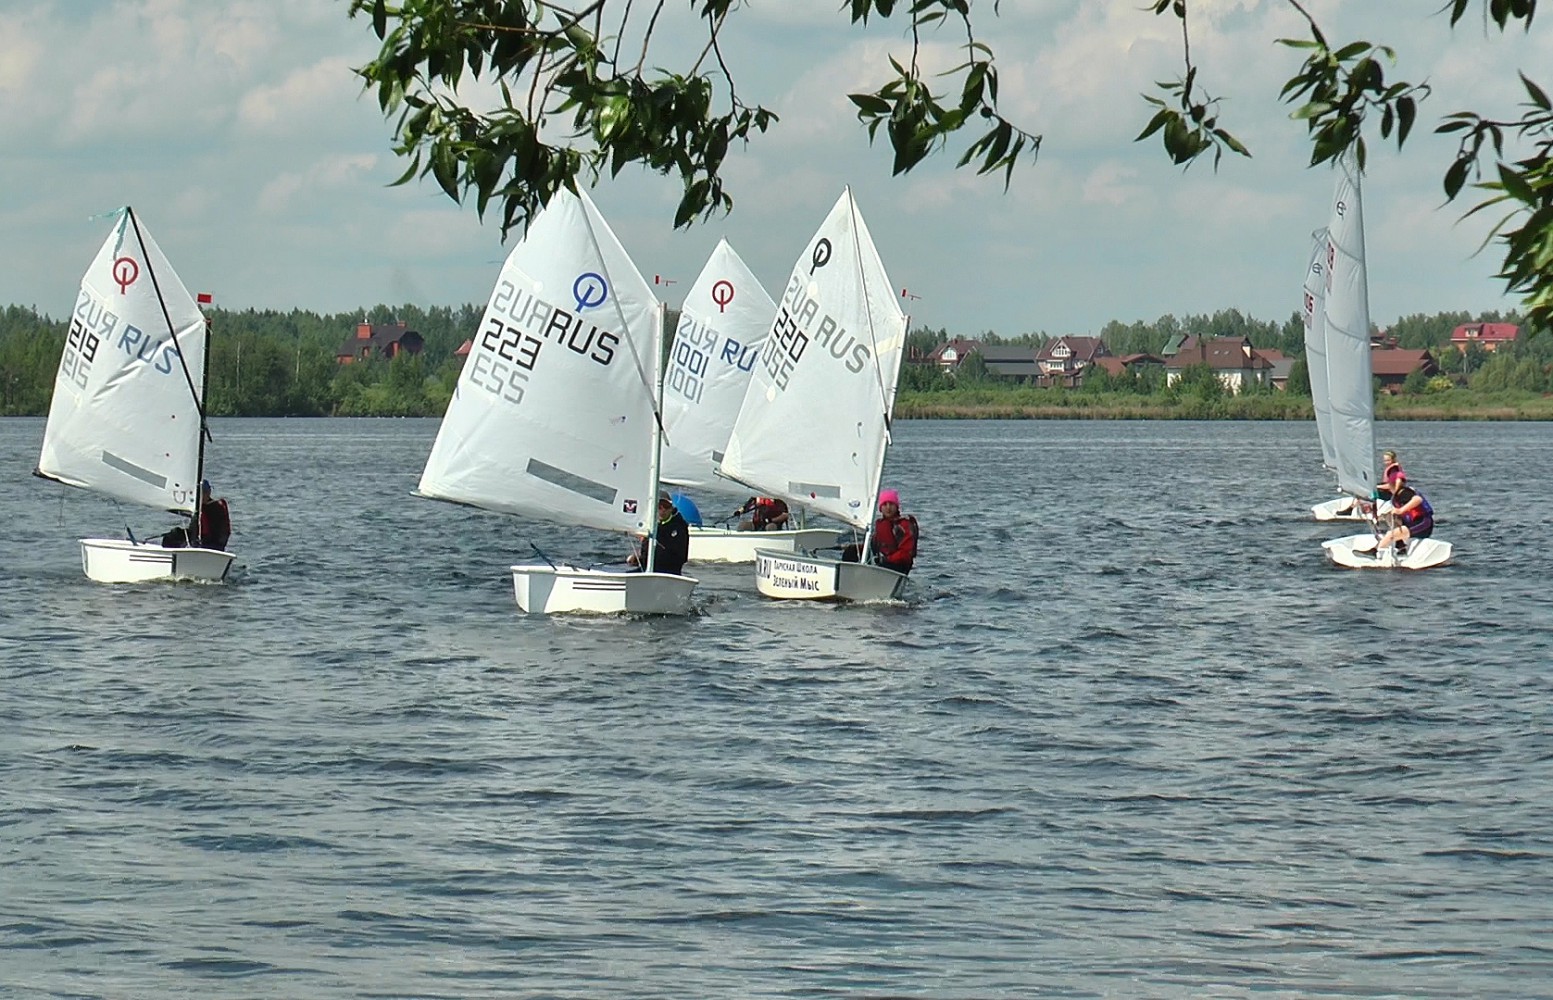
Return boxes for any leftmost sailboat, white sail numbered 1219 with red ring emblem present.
[34,208,235,584]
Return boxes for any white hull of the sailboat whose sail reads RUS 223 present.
[512,565,699,615]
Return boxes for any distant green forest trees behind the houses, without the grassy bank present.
[0,304,1553,416]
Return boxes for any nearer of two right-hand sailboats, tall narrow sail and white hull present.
[1322,155,1451,570]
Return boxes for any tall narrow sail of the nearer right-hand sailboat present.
[1326,155,1374,497]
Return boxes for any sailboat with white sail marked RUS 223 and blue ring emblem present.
[416,189,696,615]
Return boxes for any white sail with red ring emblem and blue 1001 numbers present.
[662,239,777,488]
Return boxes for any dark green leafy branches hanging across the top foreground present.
[349,0,1553,326]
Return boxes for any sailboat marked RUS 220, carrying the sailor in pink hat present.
[722,188,907,601]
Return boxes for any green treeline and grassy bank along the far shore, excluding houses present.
[0,304,1553,419]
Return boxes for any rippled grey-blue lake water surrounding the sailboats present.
[0,419,1553,1000]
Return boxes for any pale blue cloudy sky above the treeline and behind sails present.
[0,0,1553,337]
